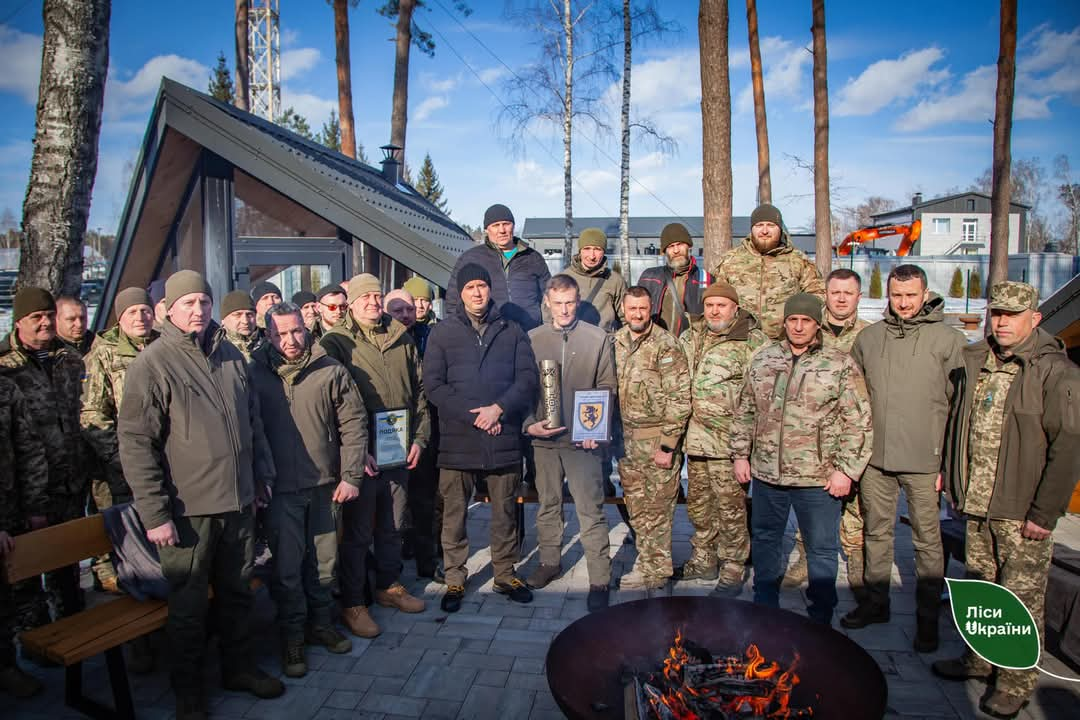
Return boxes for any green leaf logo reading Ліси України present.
[945,578,1040,670]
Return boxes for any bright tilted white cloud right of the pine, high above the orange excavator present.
[833,47,949,116]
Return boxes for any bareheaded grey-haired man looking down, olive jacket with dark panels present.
[251,302,375,678]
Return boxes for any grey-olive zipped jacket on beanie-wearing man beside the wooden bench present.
[117,320,274,529]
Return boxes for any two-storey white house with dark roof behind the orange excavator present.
[870,192,1028,255]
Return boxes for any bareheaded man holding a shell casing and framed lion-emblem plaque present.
[525,274,618,610]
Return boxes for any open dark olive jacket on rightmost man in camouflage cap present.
[945,328,1080,530]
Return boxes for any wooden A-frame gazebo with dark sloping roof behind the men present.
[95,79,473,329]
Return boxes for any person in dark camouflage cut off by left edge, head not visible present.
[0,377,49,697]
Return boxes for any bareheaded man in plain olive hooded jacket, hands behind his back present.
[840,264,966,652]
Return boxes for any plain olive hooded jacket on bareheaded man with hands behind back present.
[851,293,967,473]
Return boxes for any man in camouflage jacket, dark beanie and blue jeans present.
[731,293,874,624]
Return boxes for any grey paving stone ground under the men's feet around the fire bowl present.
[0,498,1080,720]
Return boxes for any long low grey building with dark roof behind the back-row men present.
[521,215,814,257]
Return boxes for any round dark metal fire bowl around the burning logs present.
[546,597,888,720]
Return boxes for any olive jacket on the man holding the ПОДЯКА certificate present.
[319,313,431,448]
